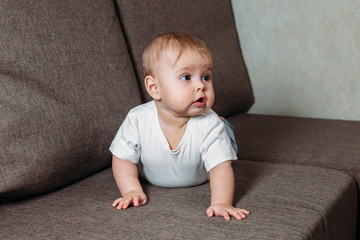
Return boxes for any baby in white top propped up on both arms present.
[110,33,250,220]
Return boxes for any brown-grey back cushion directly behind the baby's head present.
[117,0,254,116]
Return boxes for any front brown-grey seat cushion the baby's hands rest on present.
[0,161,357,240]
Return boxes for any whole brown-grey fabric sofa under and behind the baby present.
[0,0,360,240]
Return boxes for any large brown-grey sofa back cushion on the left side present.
[0,0,141,200]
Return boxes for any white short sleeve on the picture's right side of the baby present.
[200,119,237,172]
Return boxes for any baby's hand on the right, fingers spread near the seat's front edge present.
[206,204,250,220]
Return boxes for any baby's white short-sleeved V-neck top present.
[110,101,237,187]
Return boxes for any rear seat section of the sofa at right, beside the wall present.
[228,114,360,184]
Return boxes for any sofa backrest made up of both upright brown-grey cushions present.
[0,0,254,201]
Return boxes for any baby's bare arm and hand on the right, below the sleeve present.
[206,161,250,220]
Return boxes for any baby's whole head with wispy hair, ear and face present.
[143,32,215,116]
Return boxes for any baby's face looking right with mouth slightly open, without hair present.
[154,46,215,117]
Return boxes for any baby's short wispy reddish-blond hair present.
[142,32,212,76]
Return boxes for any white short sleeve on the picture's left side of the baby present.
[110,114,141,164]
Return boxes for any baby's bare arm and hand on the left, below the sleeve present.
[112,155,147,210]
